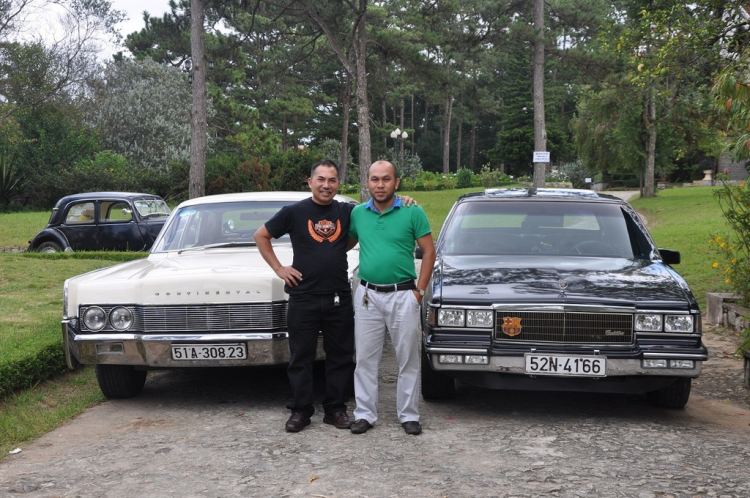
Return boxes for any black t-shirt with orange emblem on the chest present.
[266,198,354,294]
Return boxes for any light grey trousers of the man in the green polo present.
[354,285,420,424]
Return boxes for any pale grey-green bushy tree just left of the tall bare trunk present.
[89,58,191,170]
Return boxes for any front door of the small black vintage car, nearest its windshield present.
[98,200,146,251]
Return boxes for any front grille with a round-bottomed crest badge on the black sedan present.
[495,310,633,344]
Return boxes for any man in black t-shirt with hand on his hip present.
[254,160,354,432]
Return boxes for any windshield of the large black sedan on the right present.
[441,201,641,259]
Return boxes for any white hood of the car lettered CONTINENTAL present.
[67,244,358,306]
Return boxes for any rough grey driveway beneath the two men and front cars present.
[0,320,750,498]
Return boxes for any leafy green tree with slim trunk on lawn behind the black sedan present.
[573,0,739,195]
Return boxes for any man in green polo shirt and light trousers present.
[349,161,435,435]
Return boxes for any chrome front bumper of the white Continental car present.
[62,320,325,369]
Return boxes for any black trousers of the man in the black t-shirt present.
[287,292,354,415]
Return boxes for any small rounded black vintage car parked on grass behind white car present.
[28,192,170,252]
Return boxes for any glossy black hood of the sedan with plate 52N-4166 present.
[433,256,697,308]
